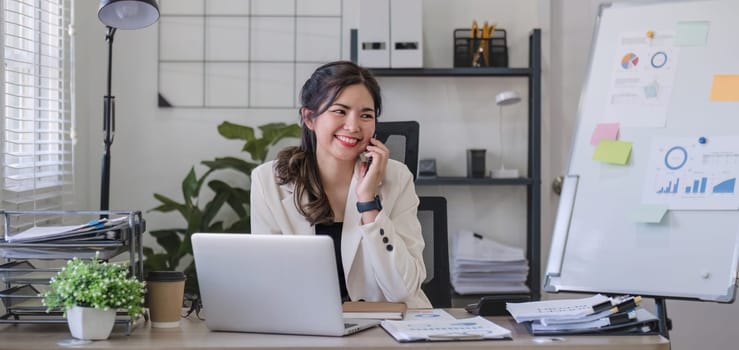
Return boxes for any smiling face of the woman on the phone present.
[304,84,375,163]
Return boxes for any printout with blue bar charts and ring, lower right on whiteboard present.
[642,136,739,210]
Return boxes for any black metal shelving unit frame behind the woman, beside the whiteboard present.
[372,29,541,301]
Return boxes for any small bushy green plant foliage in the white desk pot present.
[43,256,144,319]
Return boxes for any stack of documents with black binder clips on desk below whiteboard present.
[506,294,659,335]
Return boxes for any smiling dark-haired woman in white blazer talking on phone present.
[251,61,431,308]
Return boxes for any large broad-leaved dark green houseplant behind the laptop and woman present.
[144,122,301,298]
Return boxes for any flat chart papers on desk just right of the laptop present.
[380,316,511,343]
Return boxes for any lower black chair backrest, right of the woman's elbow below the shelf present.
[418,196,452,308]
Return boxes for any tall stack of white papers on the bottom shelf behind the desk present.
[450,231,529,294]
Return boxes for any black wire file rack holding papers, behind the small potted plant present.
[0,210,148,334]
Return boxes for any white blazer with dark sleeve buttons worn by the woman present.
[251,159,431,308]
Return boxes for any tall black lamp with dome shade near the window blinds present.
[98,0,159,210]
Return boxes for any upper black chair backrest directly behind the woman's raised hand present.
[375,121,420,180]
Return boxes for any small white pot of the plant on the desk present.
[67,306,115,340]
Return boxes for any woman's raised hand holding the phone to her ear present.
[356,138,390,202]
